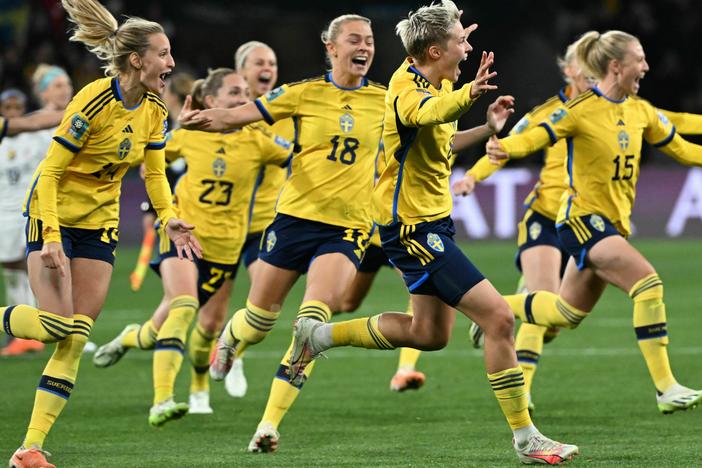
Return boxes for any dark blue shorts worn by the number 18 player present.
[258,213,370,273]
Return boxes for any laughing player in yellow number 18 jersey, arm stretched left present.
[180,15,385,451]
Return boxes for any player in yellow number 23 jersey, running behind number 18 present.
[95,68,290,426]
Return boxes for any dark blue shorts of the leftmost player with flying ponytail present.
[24,217,119,265]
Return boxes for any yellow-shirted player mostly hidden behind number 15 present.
[462,43,702,411]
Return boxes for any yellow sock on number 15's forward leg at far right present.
[629,273,677,393]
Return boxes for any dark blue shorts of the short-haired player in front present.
[379,216,485,306]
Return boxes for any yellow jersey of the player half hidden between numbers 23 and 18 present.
[249,119,295,233]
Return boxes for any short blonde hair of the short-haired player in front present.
[395,0,461,60]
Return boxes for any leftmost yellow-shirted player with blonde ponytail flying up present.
[0,0,199,468]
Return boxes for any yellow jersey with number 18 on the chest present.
[254,72,385,230]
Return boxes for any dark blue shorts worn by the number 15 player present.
[556,214,621,270]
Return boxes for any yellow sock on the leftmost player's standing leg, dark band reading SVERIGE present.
[23,314,93,448]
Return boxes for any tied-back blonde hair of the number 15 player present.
[575,31,638,80]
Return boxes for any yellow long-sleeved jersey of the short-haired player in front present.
[380,59,474,225]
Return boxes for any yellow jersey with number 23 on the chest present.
[166,125,290,264]
